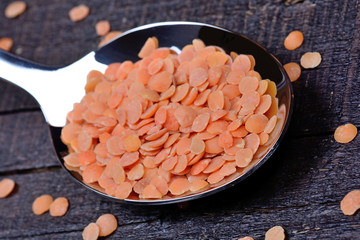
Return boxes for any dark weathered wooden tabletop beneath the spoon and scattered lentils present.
[0,0,360,240]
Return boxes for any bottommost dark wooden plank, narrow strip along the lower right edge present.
[117,205,360,239]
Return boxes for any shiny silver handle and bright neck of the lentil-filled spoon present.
[0,50,106,127]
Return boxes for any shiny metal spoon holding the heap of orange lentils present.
[0,22,293,205]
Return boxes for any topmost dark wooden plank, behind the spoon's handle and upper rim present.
[0,0,360,135]
